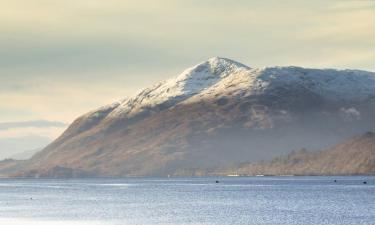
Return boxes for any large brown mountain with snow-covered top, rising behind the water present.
[11,57,375,177]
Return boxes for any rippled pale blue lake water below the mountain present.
[0,177,375,225]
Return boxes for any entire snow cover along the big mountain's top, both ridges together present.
[97,57,375,121]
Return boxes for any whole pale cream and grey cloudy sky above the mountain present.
[0,0,375,159]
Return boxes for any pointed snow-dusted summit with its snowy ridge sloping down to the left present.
[110,57,250,116]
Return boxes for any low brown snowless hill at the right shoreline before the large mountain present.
[217,132,375,175]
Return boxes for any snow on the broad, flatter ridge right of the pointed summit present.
[195,67,375,101]
